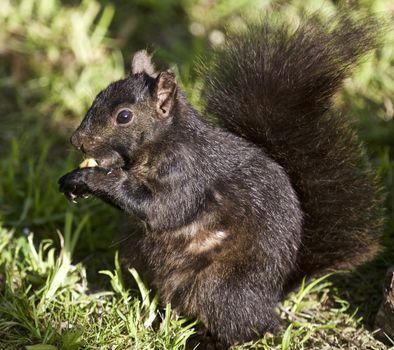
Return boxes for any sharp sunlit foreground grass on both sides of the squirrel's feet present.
[0,227,387,350]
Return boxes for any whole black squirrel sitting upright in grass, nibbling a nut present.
[59,13,382,346]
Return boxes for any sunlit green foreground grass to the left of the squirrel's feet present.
[0,226,193,350]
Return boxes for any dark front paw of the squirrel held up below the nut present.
[58,168,94,203]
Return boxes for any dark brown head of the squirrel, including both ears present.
[71,50,178,168]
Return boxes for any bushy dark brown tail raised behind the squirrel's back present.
[204,10,382,280]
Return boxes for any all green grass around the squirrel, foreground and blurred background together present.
[0,0,394,350]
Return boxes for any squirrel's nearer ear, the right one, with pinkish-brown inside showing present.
[153,71,177,118]
